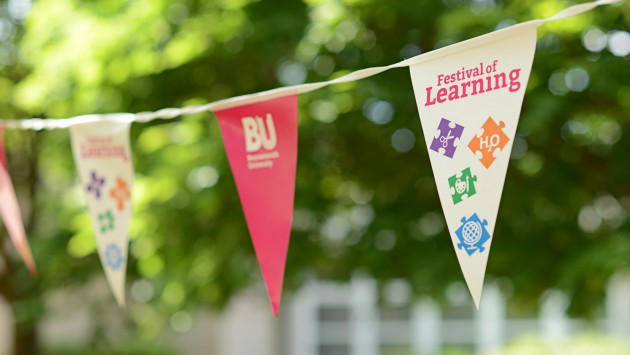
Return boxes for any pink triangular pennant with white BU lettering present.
[215,95,297,317]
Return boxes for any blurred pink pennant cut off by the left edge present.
[0,127,37,276]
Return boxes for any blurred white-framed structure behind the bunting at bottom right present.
[283,274,630,355]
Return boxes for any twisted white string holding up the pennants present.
[0,0,623,130]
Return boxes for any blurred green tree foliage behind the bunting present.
[0,0,630,350]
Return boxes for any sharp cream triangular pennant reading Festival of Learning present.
[410,24,536,307]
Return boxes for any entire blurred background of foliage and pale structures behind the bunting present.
[0,0,630,355]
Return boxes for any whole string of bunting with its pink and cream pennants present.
[0,0,619,316]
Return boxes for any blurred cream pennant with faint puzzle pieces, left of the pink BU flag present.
[70,121,134,307]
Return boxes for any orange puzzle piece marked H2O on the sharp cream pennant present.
[468,117,510,169]
